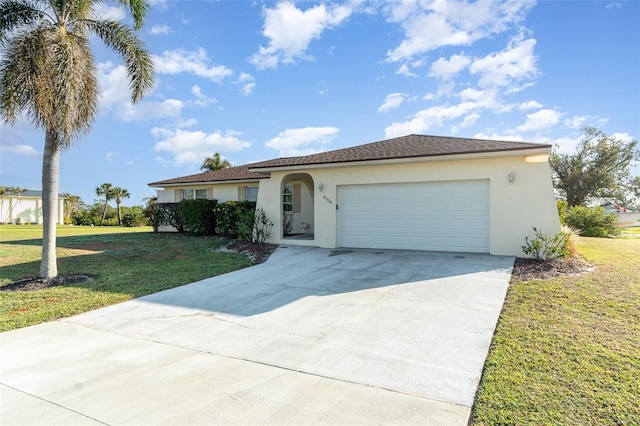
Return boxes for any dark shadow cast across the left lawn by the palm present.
[0,233,251,297]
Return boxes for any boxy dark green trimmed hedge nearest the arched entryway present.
[215,201,256,241]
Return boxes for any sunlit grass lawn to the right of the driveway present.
[471,238,640,425]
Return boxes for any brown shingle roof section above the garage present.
[249,135,551,169]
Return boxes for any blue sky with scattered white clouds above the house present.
[0,0,640,205]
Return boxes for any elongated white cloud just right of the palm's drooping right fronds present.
[152,48,233,83]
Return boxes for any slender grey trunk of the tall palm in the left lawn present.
[40,130,60,278]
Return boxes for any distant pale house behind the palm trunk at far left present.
[0,191,64,225]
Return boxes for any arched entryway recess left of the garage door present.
[280,173,315,240]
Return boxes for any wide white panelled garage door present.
[338,180,489,253]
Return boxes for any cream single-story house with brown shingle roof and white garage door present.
[149,135,560,256]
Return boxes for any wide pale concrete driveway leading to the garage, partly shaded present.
[0,246,514,425]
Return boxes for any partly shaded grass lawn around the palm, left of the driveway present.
[0,225,251,331]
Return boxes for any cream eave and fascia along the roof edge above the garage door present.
[249,145,551,173]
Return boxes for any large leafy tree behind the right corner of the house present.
[549,127,640,206]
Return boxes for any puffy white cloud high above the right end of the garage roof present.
[469,35,538,91]
